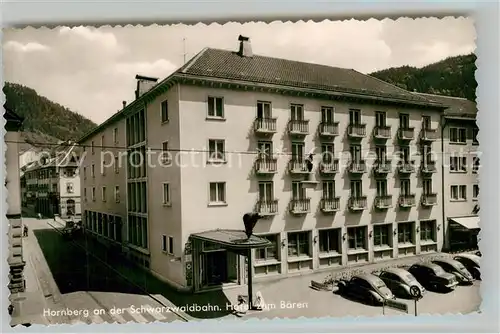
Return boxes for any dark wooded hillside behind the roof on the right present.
[370,54,477,101]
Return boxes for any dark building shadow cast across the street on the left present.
[33,228,231,319]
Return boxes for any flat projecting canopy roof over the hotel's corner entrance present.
[191,229,272,250]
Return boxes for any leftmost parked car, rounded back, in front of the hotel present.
[338,274,396,305]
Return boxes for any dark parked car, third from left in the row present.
[408,262,458,290]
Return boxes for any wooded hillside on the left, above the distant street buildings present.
[3,82,97,142]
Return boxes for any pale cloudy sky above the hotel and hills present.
[2,17,476,124]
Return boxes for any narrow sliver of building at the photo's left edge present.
[4,108,25,293]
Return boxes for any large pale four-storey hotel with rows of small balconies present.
[79,36,445,291]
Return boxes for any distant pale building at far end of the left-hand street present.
[21,142,81,218]
